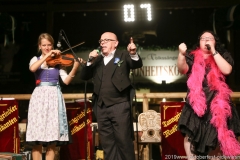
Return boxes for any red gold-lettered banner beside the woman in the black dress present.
[160,102,186,160]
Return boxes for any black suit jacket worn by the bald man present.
[80,50,143,95]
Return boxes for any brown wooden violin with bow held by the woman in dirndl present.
[46,42,86,67]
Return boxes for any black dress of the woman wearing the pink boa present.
[178,52,240,155]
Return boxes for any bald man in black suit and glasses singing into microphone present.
[81,32,143,160]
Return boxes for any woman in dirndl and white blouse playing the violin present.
[26,33,82,160]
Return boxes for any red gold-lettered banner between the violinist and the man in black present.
[60,100,94,160]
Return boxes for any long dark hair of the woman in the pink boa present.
[189,30,227,55]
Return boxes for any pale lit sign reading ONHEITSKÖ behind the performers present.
[69,48,186,84]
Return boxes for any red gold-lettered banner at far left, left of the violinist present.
[0,100,20,153]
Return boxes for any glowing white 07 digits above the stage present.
[123,4,152,22]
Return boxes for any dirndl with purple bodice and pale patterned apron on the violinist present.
[26,63,71,146]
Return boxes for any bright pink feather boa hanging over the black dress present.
[187,49,240,159]
